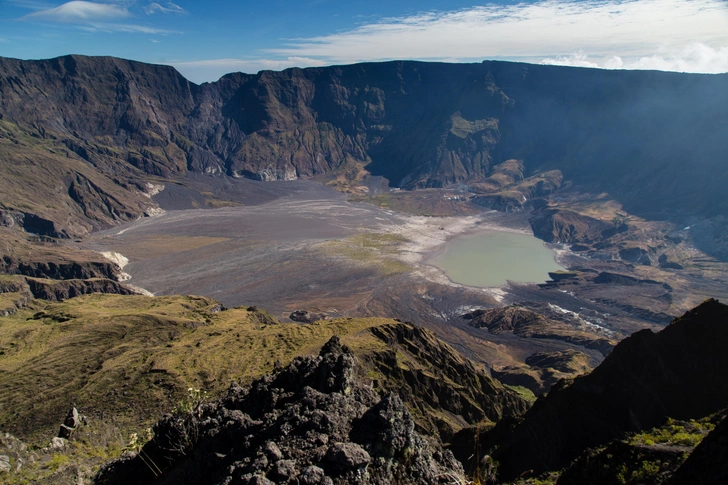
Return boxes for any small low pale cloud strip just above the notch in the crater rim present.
[171,56,327,84]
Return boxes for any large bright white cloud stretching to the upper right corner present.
[267,0,728,72]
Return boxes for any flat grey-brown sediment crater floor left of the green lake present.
[87,183,522,312]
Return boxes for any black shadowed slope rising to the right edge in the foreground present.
[472,300,728,480]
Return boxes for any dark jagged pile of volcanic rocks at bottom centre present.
[96,337,463,485]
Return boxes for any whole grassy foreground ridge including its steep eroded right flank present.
[0,294,526,440]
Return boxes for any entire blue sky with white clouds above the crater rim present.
[0,0,728,83]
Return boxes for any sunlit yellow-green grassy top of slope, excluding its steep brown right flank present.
[0,294,404,441]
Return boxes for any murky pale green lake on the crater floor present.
[427,231,564,287]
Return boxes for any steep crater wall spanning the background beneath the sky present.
[0,55,728,236]
